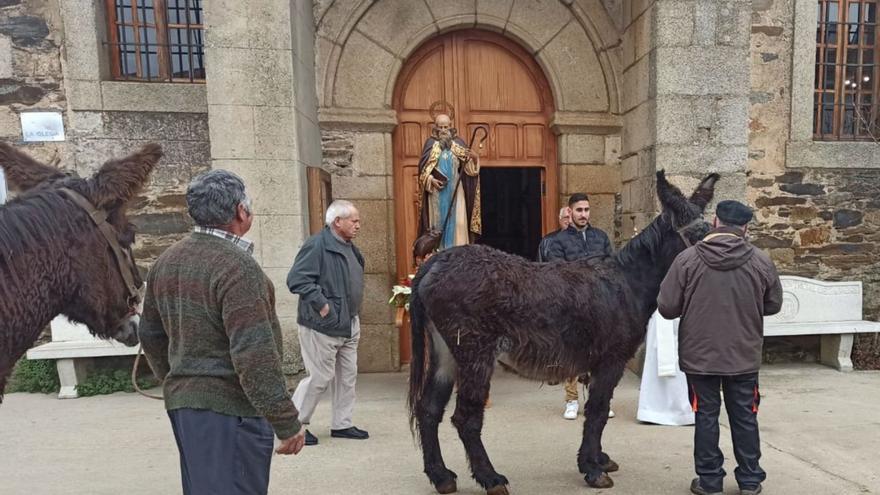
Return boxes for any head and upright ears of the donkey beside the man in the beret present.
[655,170,720,266]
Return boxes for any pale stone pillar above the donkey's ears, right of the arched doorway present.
[653,0,752,200]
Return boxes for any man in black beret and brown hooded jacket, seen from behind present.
[657,201,782,495]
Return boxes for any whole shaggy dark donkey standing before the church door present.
[409,171,718,495]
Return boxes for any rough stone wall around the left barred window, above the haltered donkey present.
[0,0,210,276]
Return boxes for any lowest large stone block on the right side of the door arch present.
[540,20,609,112]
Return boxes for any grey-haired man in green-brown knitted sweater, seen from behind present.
[138,170,305,495]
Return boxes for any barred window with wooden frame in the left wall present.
[106,0,205,83]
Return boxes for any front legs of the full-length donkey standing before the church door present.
[578,362,625,488]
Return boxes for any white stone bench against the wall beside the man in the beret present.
[764,275,880,371]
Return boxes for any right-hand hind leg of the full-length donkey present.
[452,349,507,495]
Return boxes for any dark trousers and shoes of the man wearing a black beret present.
[687,373,767,492]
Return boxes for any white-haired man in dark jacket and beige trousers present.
[287,200,370,445]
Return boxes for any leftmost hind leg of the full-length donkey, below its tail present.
[416,372,458,493]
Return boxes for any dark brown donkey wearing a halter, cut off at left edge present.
[0,143,162,401]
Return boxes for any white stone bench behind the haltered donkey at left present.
[27,315,138,399]
